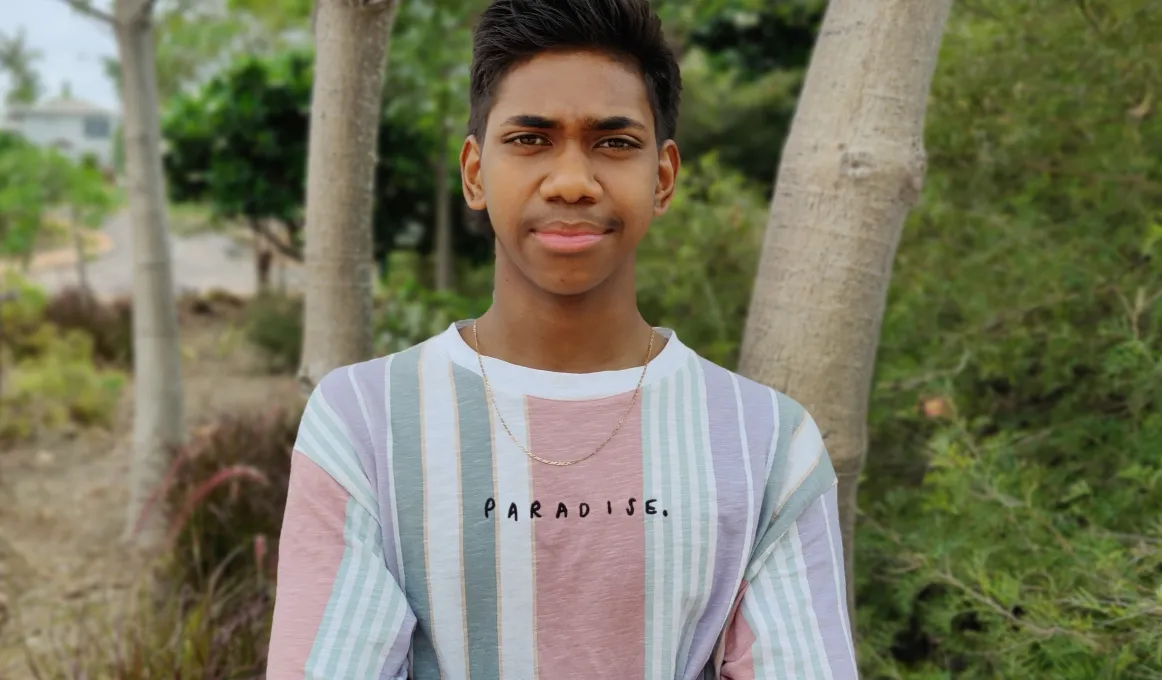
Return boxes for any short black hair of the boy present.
[468,0,682,144]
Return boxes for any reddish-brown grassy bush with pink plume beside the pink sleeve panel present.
[164,406,302,592]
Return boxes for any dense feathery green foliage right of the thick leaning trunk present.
[856,0,1162,680]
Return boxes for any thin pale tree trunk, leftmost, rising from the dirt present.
[115,0,185,545]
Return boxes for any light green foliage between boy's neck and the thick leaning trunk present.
[637,155,767,366]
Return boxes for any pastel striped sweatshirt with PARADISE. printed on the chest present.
[267,322,856,680]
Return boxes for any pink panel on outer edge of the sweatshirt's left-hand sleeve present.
[266,451,349,680]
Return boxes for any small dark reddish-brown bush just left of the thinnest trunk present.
[44,287,134,367]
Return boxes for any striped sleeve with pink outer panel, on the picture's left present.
[266,383,416,680]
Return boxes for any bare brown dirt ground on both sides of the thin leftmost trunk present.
[0,323,296,680]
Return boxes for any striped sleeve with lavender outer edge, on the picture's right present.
[718,400,858,680]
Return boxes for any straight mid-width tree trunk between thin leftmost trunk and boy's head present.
[299,0,396,391]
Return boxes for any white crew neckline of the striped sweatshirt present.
[431,320,691,400]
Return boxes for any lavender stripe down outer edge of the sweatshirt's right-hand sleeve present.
[797,486,856,680]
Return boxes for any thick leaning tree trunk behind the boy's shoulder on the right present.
[740,0,952,613]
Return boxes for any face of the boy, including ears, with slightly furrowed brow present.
[460,51,680,295]
